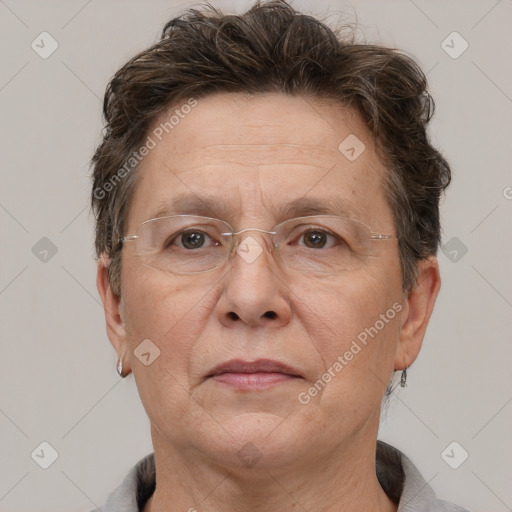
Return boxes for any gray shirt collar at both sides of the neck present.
[93,441,468,512]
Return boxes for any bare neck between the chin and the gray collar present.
[144,432,397,512]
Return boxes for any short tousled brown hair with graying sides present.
[92,0,451,295]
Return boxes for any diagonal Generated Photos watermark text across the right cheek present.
[297,302,403,405]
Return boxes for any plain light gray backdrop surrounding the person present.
[0,0,512,512]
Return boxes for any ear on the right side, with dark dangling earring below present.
[395,256,441,370]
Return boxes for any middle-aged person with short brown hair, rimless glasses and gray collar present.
[92,0,463,512]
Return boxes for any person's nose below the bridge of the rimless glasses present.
[217,230,291,327]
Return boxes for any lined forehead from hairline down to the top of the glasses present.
[129,93,390,227]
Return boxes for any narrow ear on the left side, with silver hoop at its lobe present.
[96,255,131,375]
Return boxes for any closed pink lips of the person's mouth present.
[207,359,302,390]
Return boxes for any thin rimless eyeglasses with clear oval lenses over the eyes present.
[120,215,394,274]
